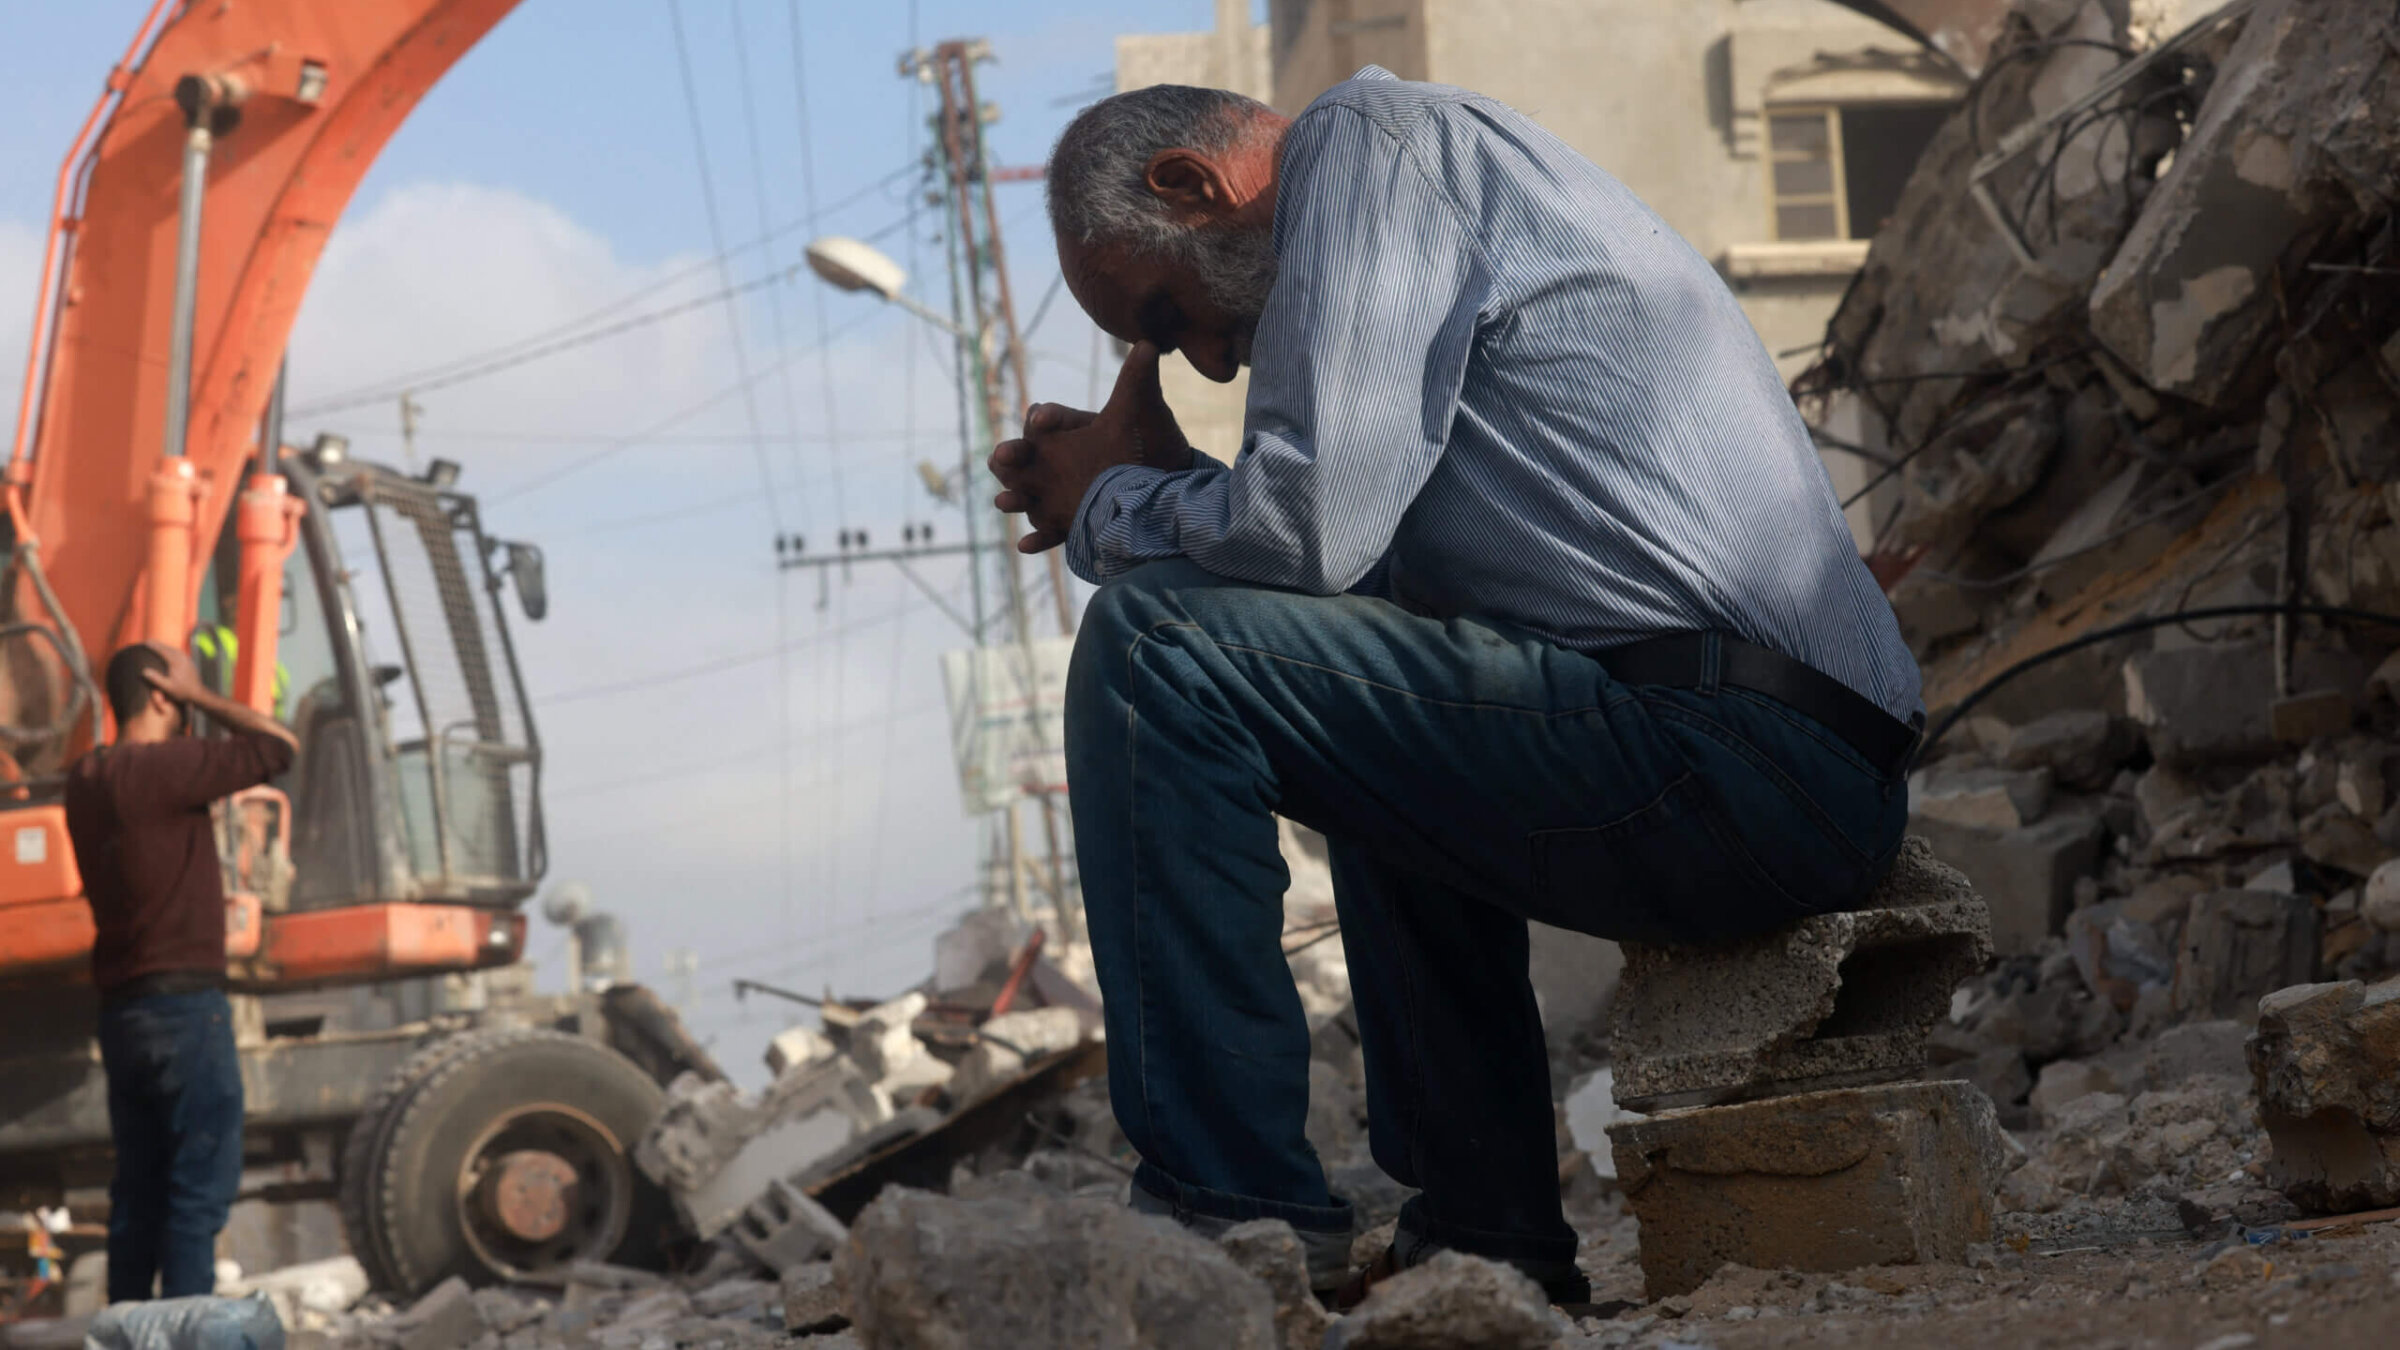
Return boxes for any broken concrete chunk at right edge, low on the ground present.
[2249,978,2400,1213]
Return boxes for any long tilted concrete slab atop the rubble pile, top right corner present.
[2090,0,2400,404]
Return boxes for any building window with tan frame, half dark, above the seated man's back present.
[1766,103,1951,240]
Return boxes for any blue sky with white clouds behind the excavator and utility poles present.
[0,0,1248,1079]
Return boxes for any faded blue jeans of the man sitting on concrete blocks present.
[1066,560,1908,1268]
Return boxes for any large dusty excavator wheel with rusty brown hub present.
[341,1031,672,1297]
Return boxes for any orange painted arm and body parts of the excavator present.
[0,0,523,987]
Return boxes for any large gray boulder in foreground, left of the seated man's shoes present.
[835,1187,1277,1350]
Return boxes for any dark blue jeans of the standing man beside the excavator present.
[101,990,242,1302]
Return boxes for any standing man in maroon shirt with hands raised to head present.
[65,644,300,1302]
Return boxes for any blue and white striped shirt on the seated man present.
[1066,67,1922,721]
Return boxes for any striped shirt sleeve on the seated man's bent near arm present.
[1066,106,1490,596]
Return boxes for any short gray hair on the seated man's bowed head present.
[1046,84,1270,259]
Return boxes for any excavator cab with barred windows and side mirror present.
[262,437,547,910]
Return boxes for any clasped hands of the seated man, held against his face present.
[991,341,1193,552]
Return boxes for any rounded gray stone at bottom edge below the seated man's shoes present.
[1325,1252,1572,1350]
